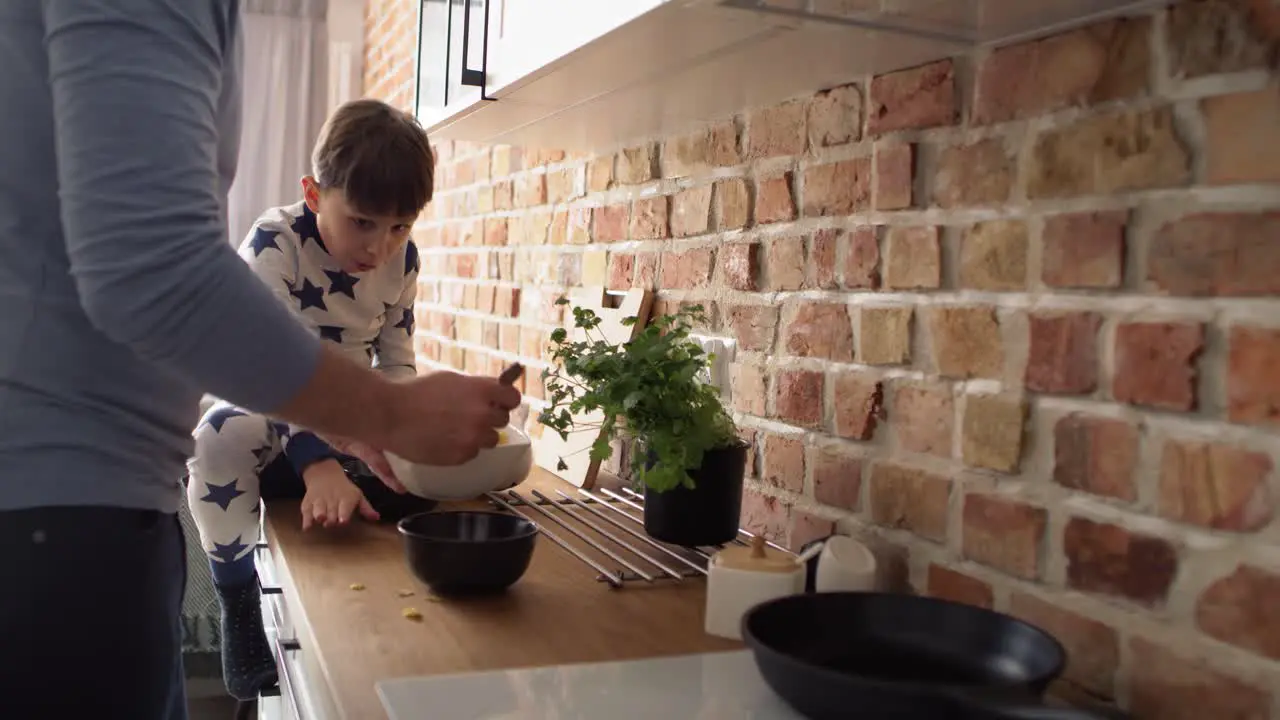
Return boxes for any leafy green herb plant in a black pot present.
[538,299,748,547]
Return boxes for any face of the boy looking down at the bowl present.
[302,176,416,273]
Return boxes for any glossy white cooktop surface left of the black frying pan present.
[378,650,803,720]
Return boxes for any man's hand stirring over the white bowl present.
[370,372,521,465]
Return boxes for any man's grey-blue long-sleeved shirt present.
[0,0,320,511]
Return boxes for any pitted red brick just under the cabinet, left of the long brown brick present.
[867,60,960,135]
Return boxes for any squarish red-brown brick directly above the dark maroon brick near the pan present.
[1053,414,1140,502]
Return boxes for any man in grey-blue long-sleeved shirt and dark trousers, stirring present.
[0,0,520,720]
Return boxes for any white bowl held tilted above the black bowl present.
[387,425,534,500]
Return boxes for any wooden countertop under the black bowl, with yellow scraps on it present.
[259,469,741,720]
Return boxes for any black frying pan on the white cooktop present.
[742,592,1129,720]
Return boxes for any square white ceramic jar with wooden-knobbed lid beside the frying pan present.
[704,536,805,641]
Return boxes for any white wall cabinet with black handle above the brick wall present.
[419,0,1167,152]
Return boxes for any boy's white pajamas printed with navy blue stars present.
[187,202,420,562]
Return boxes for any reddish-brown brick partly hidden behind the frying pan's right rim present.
[1009,592,1120,698]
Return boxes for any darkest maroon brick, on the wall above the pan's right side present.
[1062,518,1178,606]
